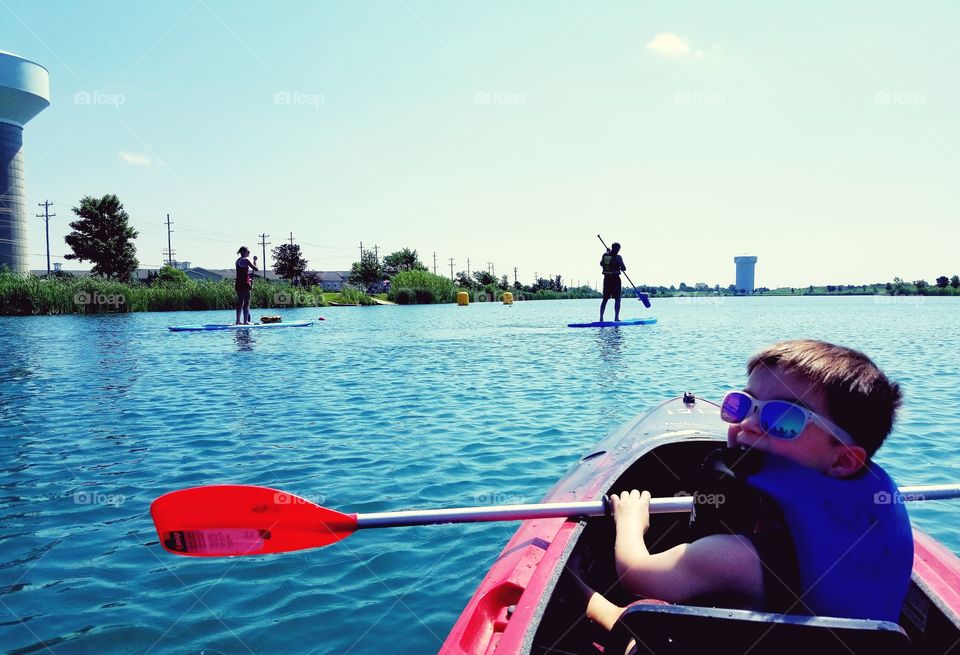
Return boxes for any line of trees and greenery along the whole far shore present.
[0,194,960,314]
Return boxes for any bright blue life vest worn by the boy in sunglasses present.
[747,454,913,621]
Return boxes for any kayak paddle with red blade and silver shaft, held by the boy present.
[150,484,960,557]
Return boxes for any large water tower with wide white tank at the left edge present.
[0,50,50,273]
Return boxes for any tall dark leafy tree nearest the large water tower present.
[64,194,139,281]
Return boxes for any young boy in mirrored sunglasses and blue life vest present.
[583,340,913,629]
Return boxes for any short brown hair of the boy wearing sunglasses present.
[747,339,901,457]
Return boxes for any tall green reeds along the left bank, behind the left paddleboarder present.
[0,271,325,316]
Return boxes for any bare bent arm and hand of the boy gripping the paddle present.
[611,491,763,603]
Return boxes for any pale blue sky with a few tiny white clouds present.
[0,0,960,288]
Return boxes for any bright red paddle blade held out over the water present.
[150,485,357,557]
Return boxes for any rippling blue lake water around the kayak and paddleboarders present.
[0,297,960,655]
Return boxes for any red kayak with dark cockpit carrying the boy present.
[440,397,960,655]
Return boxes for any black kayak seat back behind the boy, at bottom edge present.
[604,604,910,655]
